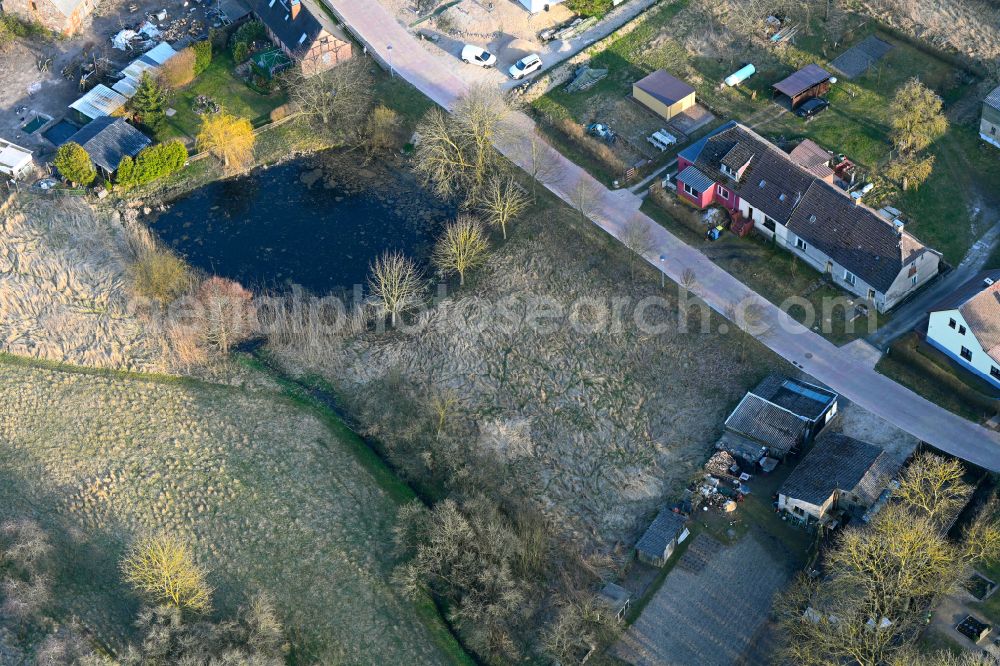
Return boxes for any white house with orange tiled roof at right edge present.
[927,270,1000,389]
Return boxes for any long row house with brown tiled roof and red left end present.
[676,122,941,312]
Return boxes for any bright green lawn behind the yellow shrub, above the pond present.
[157,50,287,141]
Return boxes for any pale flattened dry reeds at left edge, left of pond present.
[0,195,163,370]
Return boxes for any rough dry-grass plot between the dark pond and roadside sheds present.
[274,201,780,548]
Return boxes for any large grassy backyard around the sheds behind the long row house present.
[533,0,1000,263]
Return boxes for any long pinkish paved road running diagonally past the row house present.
[324,0,1000,471]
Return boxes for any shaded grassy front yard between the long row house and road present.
[642,191,892,345]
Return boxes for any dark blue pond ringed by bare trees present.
[152,151,455,294]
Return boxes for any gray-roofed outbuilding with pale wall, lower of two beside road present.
[778,433,901,523]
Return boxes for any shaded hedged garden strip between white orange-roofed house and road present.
[875,333,1000,423]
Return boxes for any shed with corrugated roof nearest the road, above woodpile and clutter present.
[716,374,839,462]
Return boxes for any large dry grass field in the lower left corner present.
[0,357,464,664]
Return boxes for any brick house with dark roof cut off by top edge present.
[253,0,353,76]
